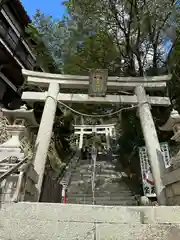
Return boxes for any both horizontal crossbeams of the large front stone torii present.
[22,69,171,106]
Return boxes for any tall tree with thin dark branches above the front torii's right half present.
[63,0,175,76]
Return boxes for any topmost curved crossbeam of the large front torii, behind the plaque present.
[22,69,171,90]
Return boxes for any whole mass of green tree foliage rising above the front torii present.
[33,0,175,76]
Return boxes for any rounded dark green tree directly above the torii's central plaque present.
[64,31,118,75]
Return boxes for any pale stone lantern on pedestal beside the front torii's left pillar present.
[0,105,38,202]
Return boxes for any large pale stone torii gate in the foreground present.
[22,70,171,205]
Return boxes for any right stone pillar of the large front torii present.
[135,85,166,205]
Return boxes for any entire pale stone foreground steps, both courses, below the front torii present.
[0,202,180,240]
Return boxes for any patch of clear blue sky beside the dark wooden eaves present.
[21,0,65,19]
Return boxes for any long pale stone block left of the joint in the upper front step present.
[0,202,140,224]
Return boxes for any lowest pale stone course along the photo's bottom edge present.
[0,219,180,240]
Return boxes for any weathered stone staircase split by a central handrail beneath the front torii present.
[67,155,137,206]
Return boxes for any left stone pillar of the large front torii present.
[34,83,60,201]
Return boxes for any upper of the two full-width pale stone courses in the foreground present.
[0,202,180,224]
